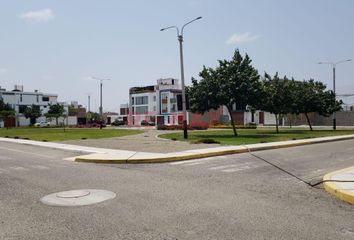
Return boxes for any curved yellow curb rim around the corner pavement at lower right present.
[323,166,354,204]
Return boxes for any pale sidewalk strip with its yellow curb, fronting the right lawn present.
[75,135,354,164]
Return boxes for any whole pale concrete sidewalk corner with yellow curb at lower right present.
[323,166,354,204]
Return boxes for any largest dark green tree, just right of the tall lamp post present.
[187,50,261,136]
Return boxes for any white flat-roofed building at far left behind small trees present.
[0,85,68,126]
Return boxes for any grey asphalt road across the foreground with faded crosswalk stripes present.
[0,140,354,240]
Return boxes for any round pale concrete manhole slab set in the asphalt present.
[41,189,116,207]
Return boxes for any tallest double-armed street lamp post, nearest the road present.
[160,17,202,139]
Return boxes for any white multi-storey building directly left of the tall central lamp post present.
[128,78,182,126]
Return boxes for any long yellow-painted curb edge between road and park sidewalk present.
[75,135,354,164]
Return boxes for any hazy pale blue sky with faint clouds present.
[0,0,354,112]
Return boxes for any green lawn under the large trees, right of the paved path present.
[159,128,354,145]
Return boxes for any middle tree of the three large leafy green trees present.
[256,73,295,133]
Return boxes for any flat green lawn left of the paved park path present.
[0,127,143,142]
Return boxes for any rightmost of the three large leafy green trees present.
[293,79,343,131]
